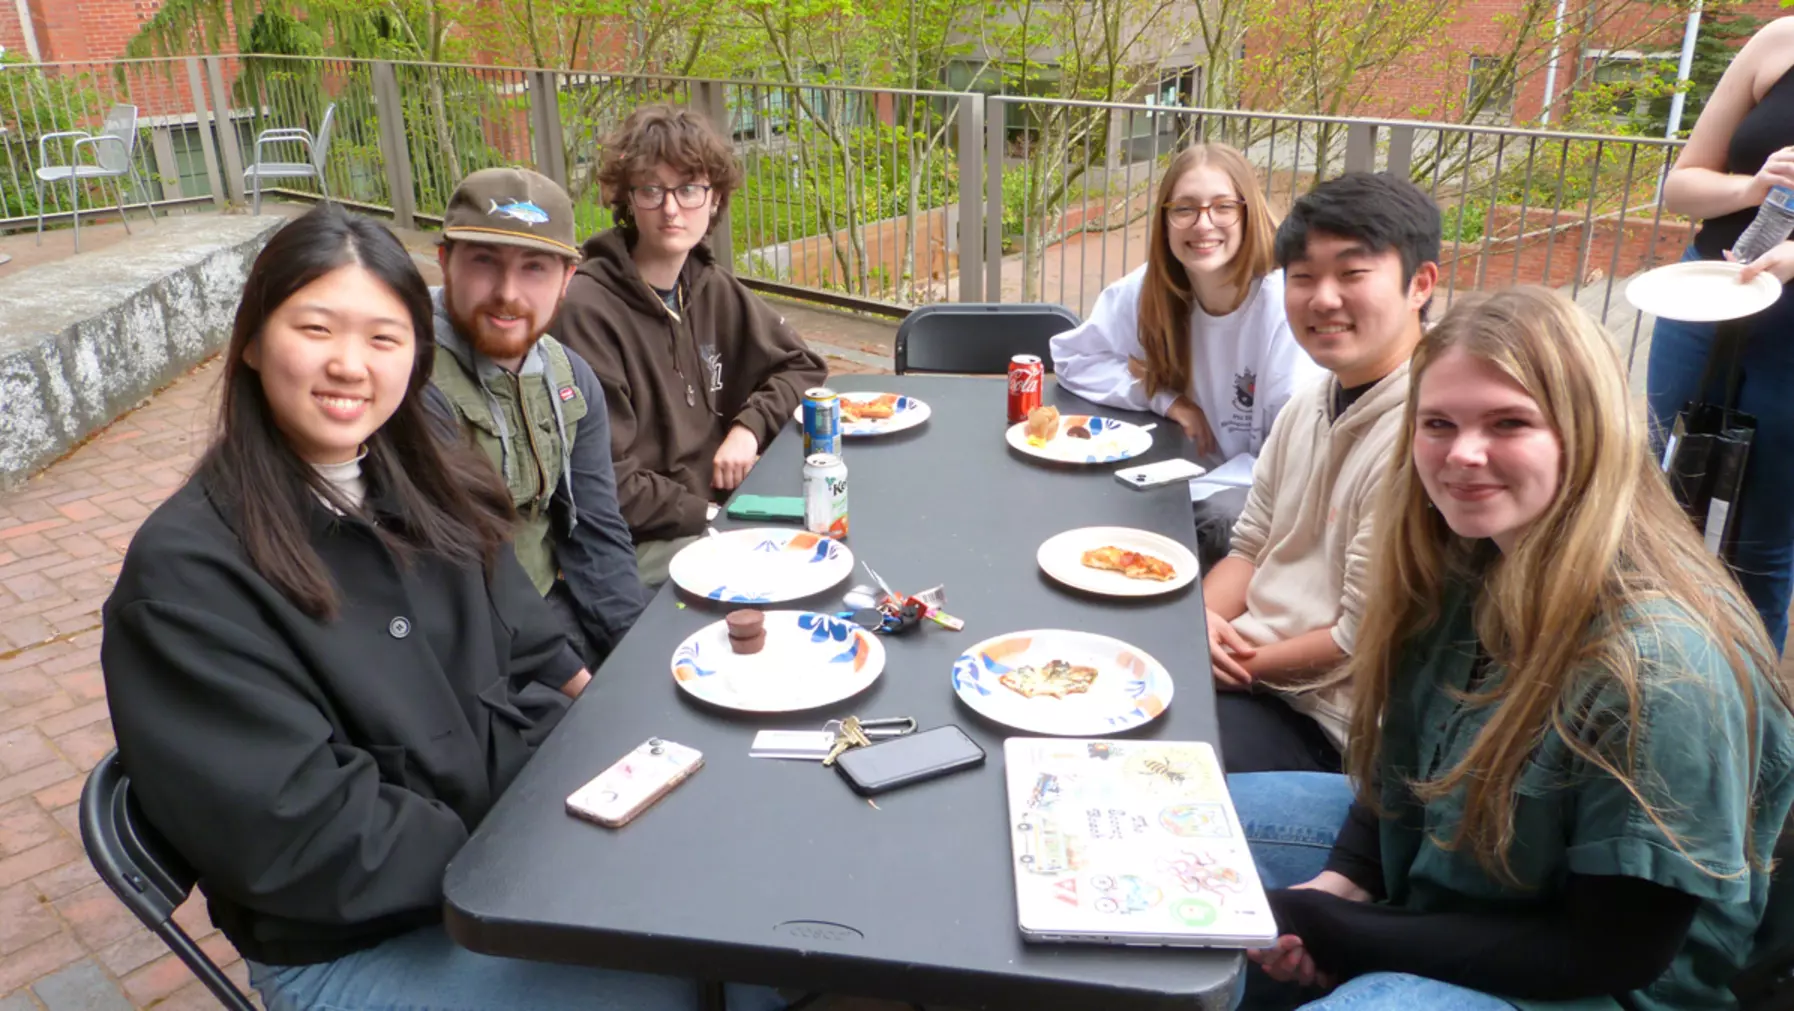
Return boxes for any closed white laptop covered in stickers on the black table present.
[1003,737,1277,948]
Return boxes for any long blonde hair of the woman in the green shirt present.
[1344,287,1789,882]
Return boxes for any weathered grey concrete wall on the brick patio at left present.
[0,215,285,488]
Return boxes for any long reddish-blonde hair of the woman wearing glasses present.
[1132,143,1277,396]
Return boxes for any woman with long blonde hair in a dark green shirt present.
[1231,289,1794,1011]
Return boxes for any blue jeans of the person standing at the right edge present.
[1645,247,1794,651]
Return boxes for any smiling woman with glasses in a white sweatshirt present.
[1053,143,1324,568]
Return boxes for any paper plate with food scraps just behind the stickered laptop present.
[953,629,1171,737]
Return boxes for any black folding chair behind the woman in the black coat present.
[81,751,257,1011]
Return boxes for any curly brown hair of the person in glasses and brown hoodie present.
[597,106,741,242]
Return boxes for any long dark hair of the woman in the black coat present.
[196,204,515,618]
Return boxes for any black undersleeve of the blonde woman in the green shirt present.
[1268,875,1701,1000]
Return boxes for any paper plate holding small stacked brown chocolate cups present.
[673,611,884,713]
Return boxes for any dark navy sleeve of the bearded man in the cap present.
[554,348,648,652]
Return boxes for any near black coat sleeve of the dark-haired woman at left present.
[100,591,470,923]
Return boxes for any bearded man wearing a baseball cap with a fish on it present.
[425,169,646,670]
